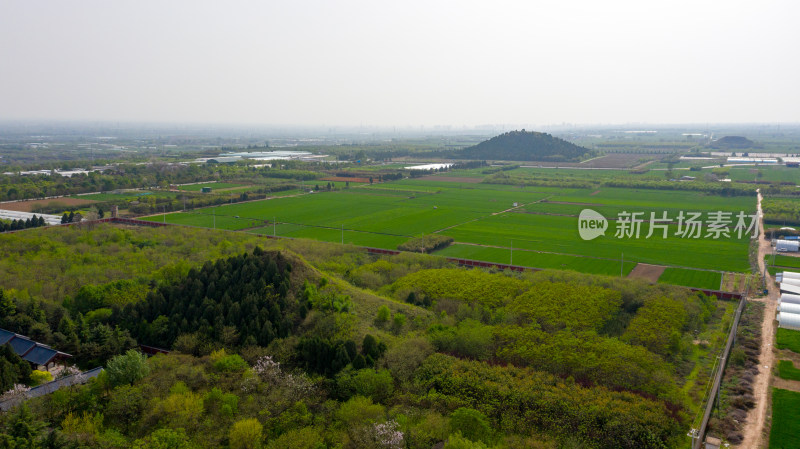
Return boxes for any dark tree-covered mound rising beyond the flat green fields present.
[458,129,597,162]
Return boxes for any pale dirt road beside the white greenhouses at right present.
[739,191,780,449]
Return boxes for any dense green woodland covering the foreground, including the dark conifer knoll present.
[0,225,731,449]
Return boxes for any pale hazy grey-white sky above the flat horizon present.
[0,0,800,126]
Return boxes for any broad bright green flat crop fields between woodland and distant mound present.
[142,178,755,280]
